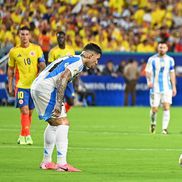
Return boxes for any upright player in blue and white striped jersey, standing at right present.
[146,42,176,134]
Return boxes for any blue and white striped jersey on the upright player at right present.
[145,54,175,93]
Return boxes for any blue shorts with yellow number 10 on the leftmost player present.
[15,88,35,109]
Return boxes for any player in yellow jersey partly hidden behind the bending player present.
[48,31,75,112]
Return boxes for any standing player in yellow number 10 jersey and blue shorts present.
[8,26,45,145]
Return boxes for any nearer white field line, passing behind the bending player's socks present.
[0,144,182,152]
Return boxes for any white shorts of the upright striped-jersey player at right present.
[150,92,172,107]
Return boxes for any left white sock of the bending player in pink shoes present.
[43,124,57,162]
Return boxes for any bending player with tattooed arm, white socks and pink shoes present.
[31,43,102,172]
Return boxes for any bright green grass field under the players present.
[0,107,182,182]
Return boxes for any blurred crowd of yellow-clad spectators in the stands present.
[0,0,182,58]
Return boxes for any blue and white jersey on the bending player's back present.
[31,55,84,93]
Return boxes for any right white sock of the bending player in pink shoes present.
[56,125,69,164]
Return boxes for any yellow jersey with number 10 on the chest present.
[8,43,45,89]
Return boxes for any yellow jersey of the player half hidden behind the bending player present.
[48,45,75,63]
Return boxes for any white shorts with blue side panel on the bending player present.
[31,90,67,121]
